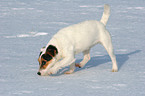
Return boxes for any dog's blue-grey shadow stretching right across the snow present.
[75,50,141,71]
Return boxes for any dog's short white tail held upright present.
[100,4,110,26]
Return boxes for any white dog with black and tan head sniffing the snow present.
[37,4,118,76]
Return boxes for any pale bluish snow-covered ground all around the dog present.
[0,0,145,96]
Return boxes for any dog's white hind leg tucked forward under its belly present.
[75,49,91,68]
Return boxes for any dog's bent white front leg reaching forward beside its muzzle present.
[48,56,75,74]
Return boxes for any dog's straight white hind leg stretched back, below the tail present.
[101,32,118,72]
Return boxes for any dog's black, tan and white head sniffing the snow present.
[37,45,58,75]
